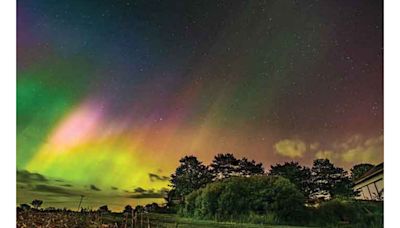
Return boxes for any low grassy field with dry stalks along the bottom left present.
[17,210,310,228]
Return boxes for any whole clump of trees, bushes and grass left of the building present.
[165,153,383,227]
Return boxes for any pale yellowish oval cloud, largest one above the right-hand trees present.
[274,139,307,158]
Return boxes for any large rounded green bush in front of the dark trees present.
[181,176,305,224]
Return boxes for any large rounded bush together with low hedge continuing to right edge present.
[180,176,383,225]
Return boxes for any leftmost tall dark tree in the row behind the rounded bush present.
[171,156,212,200]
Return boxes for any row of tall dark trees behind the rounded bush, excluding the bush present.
[166,153,373,206]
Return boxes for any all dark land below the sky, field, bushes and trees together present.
[17,153,383,227]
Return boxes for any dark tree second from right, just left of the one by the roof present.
[311,159,356,197]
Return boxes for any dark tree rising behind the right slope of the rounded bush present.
[269,162,312,198]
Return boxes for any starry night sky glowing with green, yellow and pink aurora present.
[17,0,383,208]
